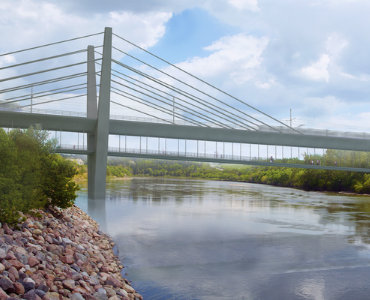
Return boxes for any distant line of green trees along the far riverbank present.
[66,150,370,193]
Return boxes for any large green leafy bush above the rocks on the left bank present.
[0,126,78,224]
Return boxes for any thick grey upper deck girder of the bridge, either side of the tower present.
[0,111,370,152]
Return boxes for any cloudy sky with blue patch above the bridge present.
[0,0,370,155]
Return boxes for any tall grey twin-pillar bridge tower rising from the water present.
[87,27,112,200]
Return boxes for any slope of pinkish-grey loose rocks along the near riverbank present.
[0,206,143,300]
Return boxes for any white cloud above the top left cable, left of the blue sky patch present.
[0,0,172,53]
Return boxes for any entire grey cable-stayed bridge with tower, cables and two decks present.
[0,28,370,199]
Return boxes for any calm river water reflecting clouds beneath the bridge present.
[76,178,370,300]
